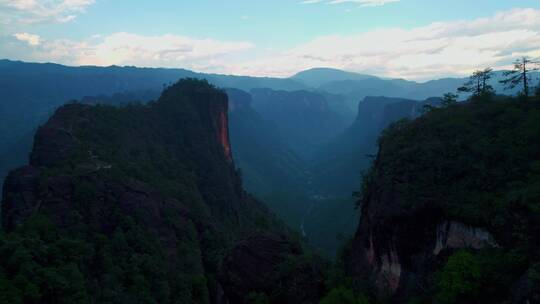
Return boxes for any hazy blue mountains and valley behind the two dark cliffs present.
[0,60,538,252]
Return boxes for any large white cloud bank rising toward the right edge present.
[223,9,540,79]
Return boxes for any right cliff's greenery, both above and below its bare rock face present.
[363,95,540,303]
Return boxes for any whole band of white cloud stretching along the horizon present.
[0,8,540,80]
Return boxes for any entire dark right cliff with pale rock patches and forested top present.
[348,100,540,303]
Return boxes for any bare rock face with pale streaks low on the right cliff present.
[349,140,497,302]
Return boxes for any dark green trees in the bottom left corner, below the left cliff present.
[0,216,198,303]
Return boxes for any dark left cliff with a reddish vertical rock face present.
[0,79,312,303]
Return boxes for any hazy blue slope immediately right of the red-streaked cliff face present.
[227,89,308,229]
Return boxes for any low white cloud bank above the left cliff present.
[5,32,253,70]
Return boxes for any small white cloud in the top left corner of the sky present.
[0,0,94,23]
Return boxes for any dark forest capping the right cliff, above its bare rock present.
[376,95,540,234]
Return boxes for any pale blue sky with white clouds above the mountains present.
[0,0,540,81]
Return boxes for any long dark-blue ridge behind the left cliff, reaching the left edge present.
[0,60,305,192]
